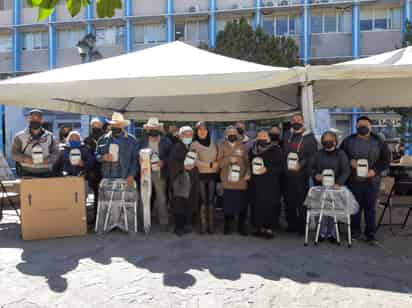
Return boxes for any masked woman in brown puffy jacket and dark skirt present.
[218,126,250,235]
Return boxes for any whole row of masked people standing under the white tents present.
[12,110,389,242]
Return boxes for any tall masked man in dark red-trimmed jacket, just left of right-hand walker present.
[282,114,317,234]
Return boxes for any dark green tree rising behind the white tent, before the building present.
[211,17,299,67]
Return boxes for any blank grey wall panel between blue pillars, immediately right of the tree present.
[311,33,352,58]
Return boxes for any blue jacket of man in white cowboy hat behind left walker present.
[96,132,138,179]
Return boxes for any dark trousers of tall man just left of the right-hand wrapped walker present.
[282,175,309,231]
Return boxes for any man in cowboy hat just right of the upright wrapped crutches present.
[138,118,171,229]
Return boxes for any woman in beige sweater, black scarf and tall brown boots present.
[190,122,219,233]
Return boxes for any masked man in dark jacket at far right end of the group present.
[341,117,390,244]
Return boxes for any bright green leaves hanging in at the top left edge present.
[24,0,122,21]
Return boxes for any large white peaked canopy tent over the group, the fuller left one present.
[0,42,305,121]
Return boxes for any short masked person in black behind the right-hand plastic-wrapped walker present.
[311,131,350,243]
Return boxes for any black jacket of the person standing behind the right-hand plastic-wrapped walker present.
[311,150,350,185]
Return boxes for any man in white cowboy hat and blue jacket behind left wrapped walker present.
[96,112,138,186]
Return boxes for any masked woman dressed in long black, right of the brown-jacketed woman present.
[250,131,283,239]
